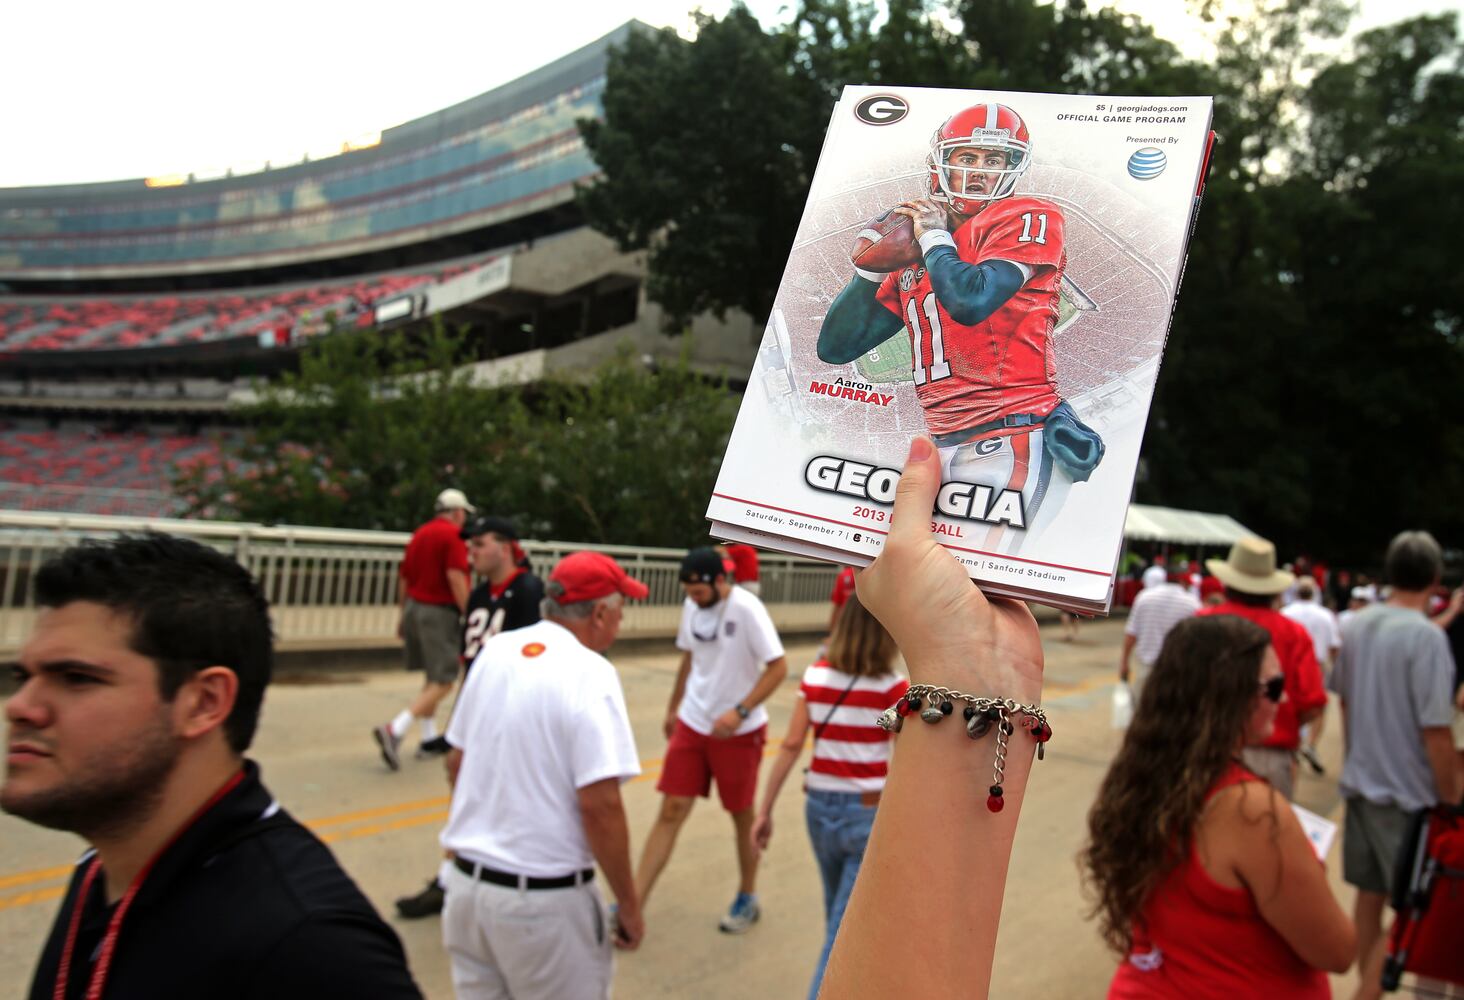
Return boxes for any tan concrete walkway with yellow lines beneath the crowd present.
[0,621,1370,1000]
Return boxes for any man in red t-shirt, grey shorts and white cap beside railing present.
[372,489,477,770]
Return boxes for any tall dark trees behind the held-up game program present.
[583,0,1464,562]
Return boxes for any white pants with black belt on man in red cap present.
[442,867,615,1000]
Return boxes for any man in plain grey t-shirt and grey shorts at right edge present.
[1331,531,1460,982]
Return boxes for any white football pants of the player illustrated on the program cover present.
[940,426,1073,555]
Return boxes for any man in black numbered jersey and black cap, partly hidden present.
[397,517,545,919]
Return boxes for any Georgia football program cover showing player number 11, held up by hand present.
[707,86,1212,612]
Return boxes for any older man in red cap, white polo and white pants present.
[442,552,647,1000]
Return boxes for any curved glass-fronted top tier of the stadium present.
[0,22,637,281]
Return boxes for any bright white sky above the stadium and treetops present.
[0,0,1464,187]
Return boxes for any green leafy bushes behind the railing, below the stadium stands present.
[176,327,736,546]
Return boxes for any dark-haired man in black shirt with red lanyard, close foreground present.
[0,534,420,1000]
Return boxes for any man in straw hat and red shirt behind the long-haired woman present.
[1199,537,1326,798]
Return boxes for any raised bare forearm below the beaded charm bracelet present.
[823,668,1039,999]
